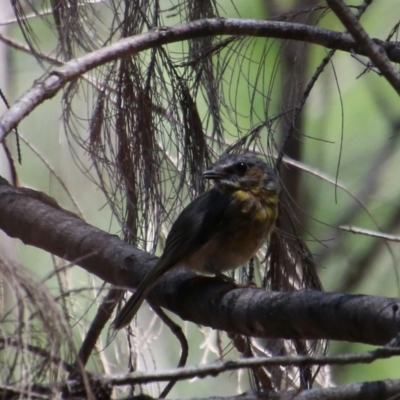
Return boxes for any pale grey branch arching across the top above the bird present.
[0,18,400,142]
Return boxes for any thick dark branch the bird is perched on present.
[0,178,400,344]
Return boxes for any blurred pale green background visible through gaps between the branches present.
[1,0,400,396]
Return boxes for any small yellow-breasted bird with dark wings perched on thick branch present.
[112,153,280,330]
